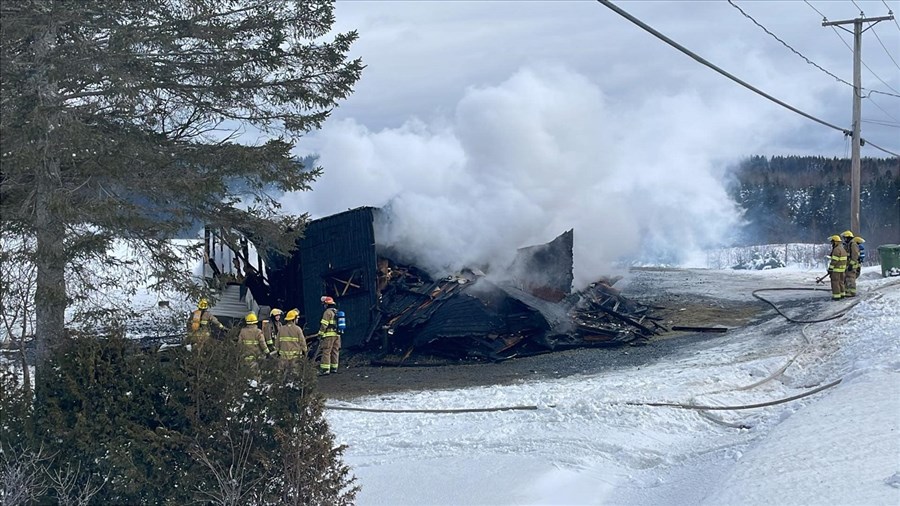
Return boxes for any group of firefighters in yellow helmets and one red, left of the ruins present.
[187,296,343,376]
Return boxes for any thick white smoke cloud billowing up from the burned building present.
[284,67,764,288]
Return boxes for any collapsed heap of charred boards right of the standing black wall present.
[372,258,665,365]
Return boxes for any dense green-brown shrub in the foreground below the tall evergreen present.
[0,336,358,505]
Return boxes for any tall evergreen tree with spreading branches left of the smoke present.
[0,0,363,380]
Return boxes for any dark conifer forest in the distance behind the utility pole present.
[728,156,900,249]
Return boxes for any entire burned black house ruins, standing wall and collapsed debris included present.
[207,207,665,361]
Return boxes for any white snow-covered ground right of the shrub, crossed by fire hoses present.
[327,267,900,506]
